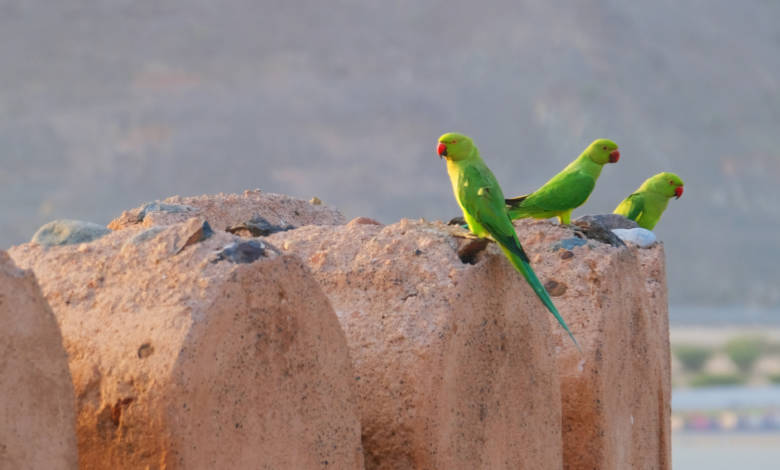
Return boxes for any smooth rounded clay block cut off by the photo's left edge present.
[0,251,78,470]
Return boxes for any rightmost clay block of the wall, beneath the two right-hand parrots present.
[516,220,671,470]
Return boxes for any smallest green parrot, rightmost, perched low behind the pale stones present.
[614,172,683,230]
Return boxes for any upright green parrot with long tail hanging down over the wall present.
[437,133,580,349]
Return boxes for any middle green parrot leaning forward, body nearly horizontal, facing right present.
[506,139,620,224]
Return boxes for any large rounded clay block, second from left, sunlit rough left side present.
[10,220,363,470]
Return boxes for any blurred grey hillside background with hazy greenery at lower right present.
[0,0,780,469]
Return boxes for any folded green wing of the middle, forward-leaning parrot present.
[505,171,596,214]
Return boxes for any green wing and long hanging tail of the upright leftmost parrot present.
[458,166,580,349]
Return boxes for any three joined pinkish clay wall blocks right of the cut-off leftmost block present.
[0,191,670,470]
